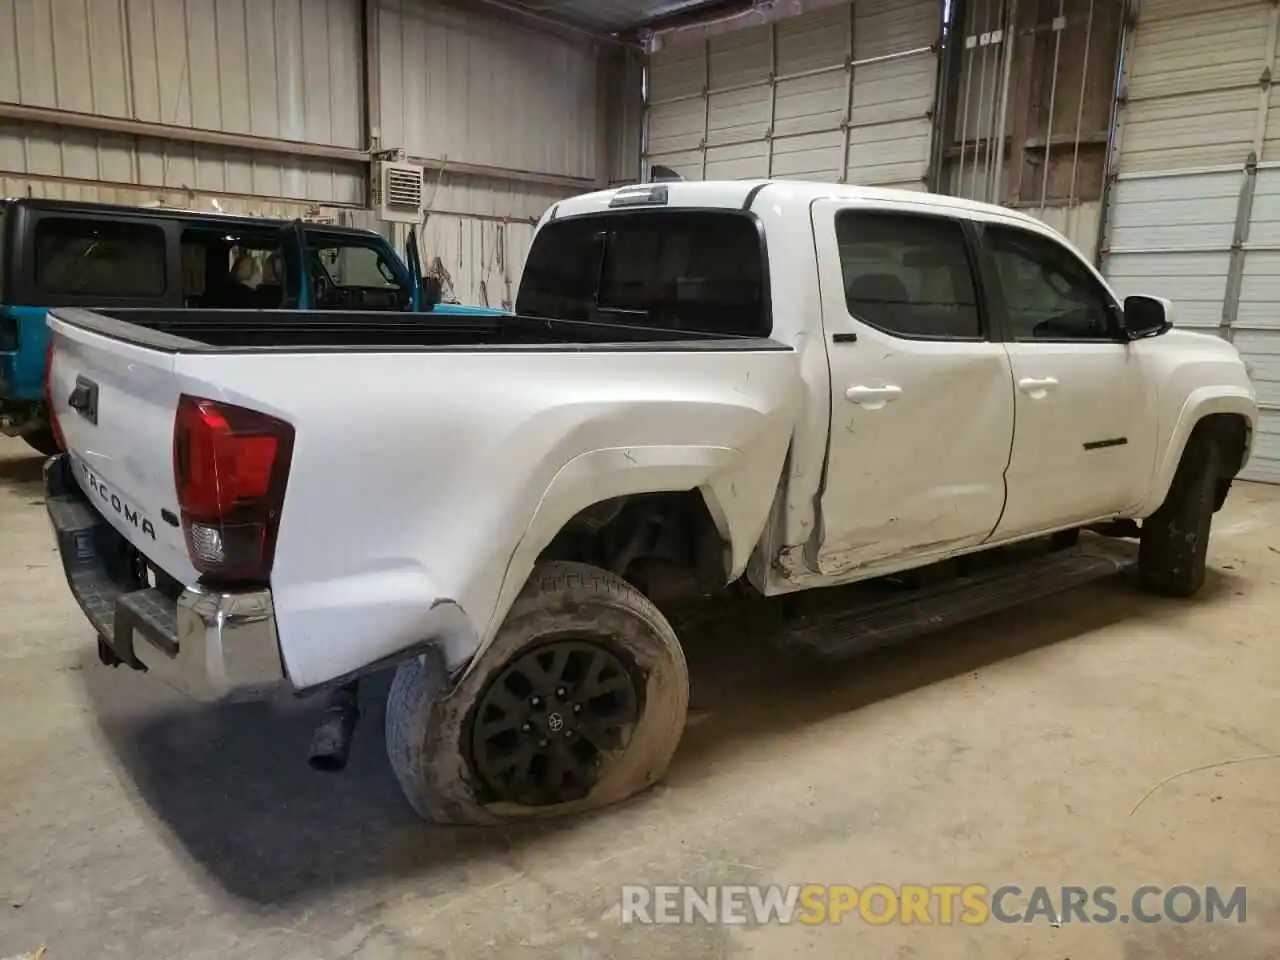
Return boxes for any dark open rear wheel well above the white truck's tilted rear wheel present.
[539,490,726,605]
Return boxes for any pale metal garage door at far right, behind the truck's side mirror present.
[1102,0,1280,483]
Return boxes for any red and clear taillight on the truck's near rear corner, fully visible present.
[173,394,293,582]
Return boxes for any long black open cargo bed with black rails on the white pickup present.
[51,308,788,353]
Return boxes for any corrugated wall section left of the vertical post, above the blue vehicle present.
[0,0,366,206]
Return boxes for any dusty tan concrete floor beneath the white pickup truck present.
[0,440,1280,960]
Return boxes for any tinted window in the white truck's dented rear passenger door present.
[836,210,983,340]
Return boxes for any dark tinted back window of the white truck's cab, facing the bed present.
[516,210,772,337]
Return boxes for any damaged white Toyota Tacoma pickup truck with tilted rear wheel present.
[45,182,1257,823]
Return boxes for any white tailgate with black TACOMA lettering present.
[49,311,196,584]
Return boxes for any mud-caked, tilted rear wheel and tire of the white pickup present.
[387,562,689,824]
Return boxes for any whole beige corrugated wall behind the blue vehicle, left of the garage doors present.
[0,0,641,306]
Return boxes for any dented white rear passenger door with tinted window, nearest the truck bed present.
[813,201,1014,579]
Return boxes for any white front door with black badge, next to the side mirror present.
[983,225,1155,540]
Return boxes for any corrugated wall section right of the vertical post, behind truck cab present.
[378,0,616,306]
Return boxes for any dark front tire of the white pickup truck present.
[1138,430,1221,596]
